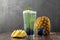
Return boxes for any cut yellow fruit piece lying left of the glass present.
[11,30,27,38]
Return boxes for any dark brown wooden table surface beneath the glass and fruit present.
[0,33,60,40]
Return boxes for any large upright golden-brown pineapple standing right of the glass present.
[36,16,51,35]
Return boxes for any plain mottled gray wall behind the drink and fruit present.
[0,0,60,32]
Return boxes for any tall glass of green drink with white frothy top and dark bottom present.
[23,10,36,35]
